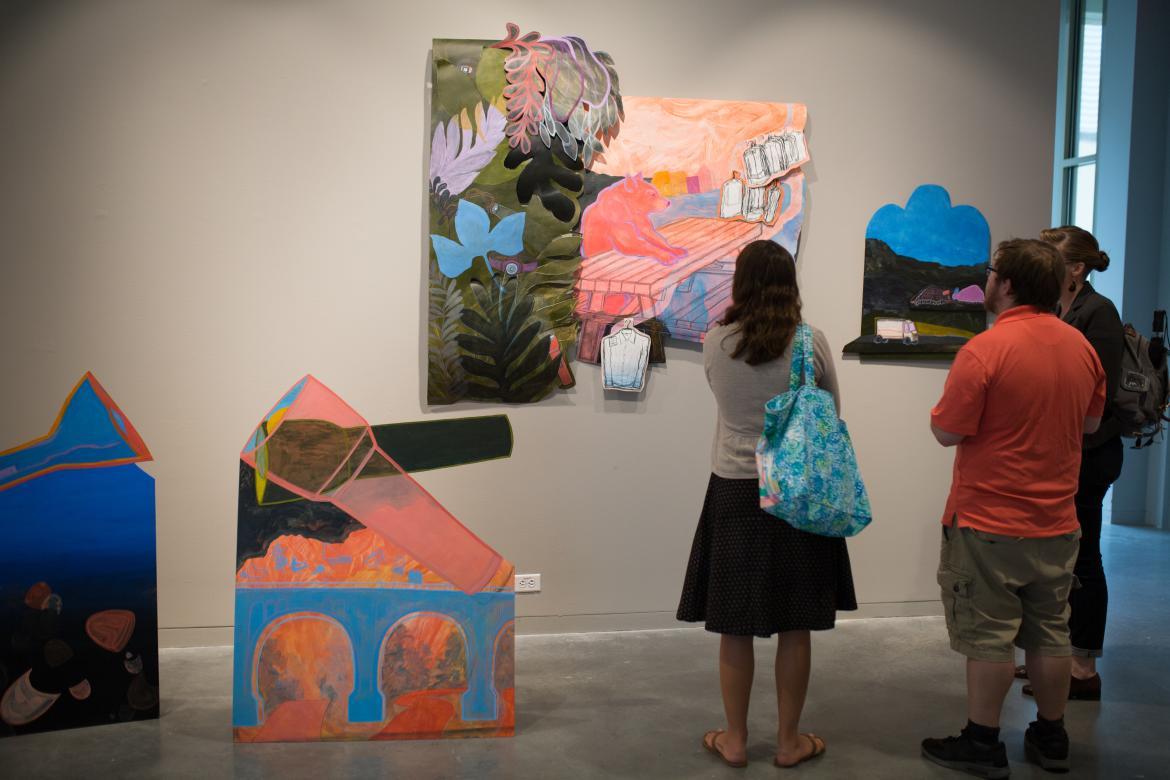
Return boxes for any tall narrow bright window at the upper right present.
[1052,0,1104,232]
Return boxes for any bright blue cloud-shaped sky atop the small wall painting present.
[866,184,991,265]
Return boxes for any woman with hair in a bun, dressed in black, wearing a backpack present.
[1034,226,1126,700]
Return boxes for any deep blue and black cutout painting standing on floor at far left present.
[0,373,158,736]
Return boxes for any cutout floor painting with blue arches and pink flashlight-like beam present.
[232,377,515,741]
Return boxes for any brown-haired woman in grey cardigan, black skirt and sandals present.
[677,241,858,767]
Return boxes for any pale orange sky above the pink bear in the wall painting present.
[592,97,807,187]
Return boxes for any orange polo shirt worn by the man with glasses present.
[930,306,1104,537]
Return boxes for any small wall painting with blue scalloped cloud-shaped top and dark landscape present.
[844,185,991,357]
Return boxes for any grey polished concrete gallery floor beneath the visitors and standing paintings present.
[0,527,1170,780]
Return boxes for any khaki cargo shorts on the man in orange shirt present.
[938,525,1081,662]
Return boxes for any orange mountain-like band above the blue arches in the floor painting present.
[235,529,515,587]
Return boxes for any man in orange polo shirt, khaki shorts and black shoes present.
[922,240,1106,778]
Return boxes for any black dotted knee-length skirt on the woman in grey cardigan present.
[677,474,858,636]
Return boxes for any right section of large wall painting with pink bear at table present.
[576,97,810,361]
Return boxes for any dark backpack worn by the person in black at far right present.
[1114,310,1170,449]
